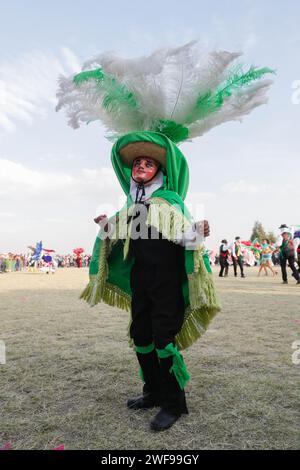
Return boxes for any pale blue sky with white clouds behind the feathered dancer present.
[0,0,300,252]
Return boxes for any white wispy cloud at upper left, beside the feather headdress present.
[0,47,79,132]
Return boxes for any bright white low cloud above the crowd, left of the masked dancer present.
[0,159,124,252]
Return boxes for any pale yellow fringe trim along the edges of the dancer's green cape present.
[80,198,220,350]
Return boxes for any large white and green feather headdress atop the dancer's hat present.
[56,41,275,143]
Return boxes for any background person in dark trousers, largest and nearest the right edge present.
[278,224,300,284]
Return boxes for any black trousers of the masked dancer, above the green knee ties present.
[130,259,184,349]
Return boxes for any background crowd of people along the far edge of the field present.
[0,224,300,284]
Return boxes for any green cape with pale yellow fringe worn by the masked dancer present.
[81,132,220,350]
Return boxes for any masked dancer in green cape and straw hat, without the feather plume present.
[82,132,219,430]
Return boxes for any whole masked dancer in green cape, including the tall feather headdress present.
[57,42,273,431]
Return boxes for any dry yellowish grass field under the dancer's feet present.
[0,268,300,450]
